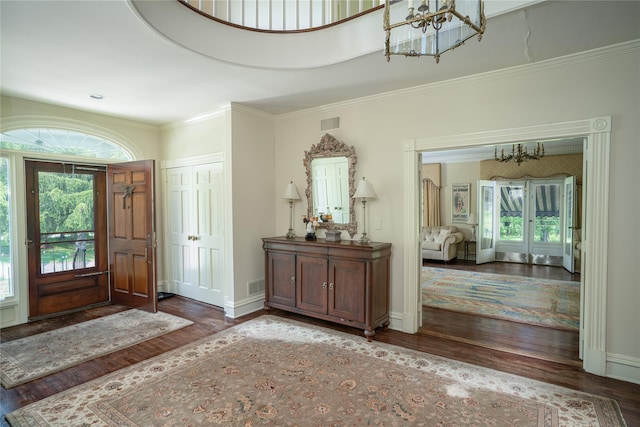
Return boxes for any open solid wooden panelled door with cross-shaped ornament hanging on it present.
[107,160,157,312]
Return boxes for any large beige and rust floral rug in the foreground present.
[7,316,625,427]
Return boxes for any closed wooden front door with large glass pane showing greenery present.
[25,161,109,318]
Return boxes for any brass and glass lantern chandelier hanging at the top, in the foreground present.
[383,0,486,63]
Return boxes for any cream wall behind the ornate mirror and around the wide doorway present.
[274,43,640,382]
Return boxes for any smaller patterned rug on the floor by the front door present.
[0,309,193,388]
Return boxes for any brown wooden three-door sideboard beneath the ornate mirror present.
[262,237,391,341]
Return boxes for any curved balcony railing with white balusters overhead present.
[178,0,384,32]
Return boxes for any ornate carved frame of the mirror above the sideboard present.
[303,133,358,238]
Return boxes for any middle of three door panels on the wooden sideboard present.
[296,256,329,314]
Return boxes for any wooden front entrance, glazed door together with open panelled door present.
[25,161,157,318]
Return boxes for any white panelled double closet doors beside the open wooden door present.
[166,162,224,307]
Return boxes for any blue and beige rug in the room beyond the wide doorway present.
[421,267,580,331]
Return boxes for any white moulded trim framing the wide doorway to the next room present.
[403,116,611,376]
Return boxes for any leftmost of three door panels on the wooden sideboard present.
[267,252,296,307]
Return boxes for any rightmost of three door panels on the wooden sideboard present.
[328,260,367,323]
